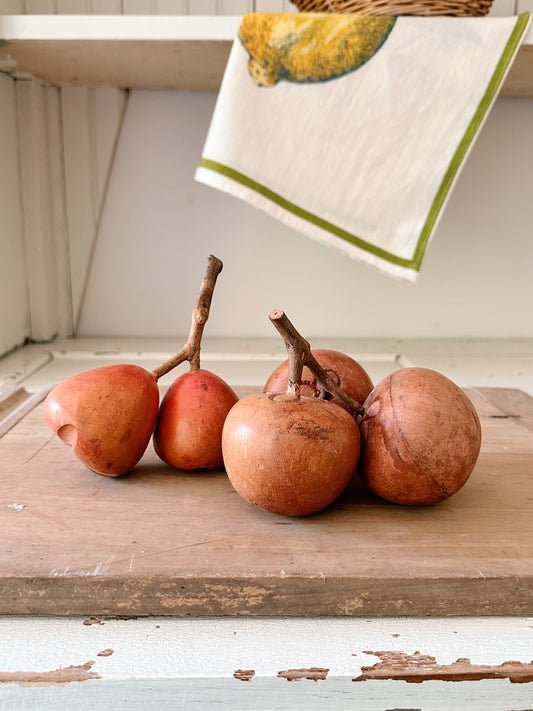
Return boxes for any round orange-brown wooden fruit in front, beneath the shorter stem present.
[218,393,360,516]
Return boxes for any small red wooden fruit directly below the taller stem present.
[154,369,239,470]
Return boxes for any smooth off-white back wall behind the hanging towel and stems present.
[78,91,533,338]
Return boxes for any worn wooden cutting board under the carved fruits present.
[0,388,533,616]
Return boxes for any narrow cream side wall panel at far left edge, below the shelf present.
[0,75,29,355]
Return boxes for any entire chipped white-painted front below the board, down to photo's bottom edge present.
[0,617,533,711]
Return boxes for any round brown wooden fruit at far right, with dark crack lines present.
[358,368,481,505]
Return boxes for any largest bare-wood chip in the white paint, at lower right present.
[353,651,533,684]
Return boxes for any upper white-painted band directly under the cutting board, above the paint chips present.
[0,616,533,680]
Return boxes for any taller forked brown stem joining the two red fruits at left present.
[152,254,222,380]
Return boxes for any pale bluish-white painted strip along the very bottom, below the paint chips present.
[0,677,533,711]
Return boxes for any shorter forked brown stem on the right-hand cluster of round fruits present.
[268,309,364,415]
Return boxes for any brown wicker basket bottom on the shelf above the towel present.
[292,0,492,17]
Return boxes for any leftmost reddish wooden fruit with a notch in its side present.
[44,364,159,477]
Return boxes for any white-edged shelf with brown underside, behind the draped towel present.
[0,15,533,97]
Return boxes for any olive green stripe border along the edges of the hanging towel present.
[200,12,530,271]
